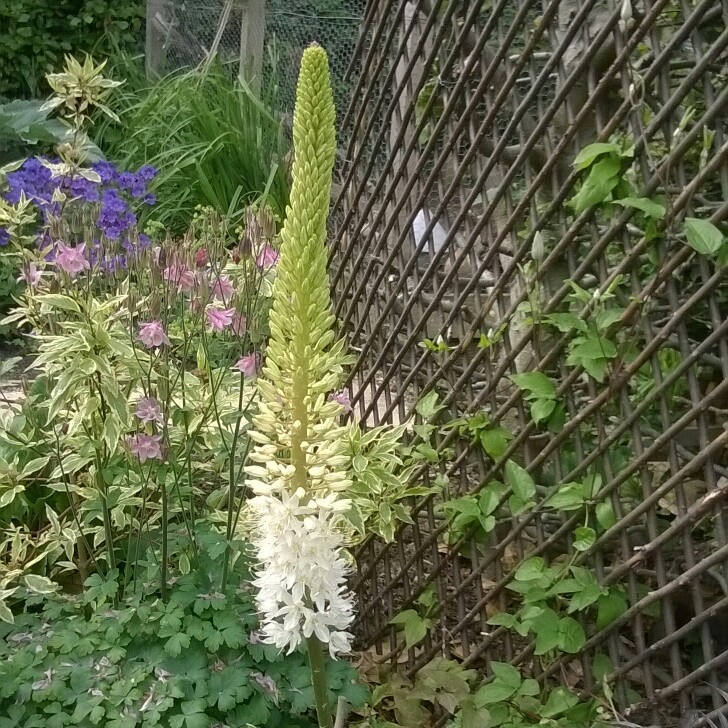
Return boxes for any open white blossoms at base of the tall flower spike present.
[248,478,353,657]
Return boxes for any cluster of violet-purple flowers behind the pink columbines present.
[0,158,157,272]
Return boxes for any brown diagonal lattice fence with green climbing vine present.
[332,0,728,725]
